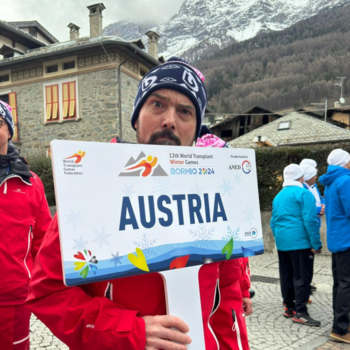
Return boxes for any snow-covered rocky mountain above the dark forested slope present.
[106,0,350,61]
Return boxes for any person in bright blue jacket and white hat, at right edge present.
[320,149,350,344]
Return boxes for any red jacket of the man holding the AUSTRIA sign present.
[26,216,252,350]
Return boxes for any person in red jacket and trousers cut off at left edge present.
[0,101,51,350]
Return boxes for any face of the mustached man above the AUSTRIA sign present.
[135,89,197,146]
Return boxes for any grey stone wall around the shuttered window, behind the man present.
[12,68,138,157]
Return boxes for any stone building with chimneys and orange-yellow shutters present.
[0,3,159,156]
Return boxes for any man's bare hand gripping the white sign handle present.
[143,315,192,350]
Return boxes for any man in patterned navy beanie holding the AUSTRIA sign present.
[27,61,252,350]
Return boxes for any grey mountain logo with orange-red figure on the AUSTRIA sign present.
[119,152,168,177]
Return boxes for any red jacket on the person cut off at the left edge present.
[0,173,52,306]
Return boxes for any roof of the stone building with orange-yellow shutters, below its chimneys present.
[0,36,159,68]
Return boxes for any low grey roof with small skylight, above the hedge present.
[229,112,350,148]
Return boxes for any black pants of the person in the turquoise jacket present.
[278,249,314,312]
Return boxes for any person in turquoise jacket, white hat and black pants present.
[271,164,322,326]
